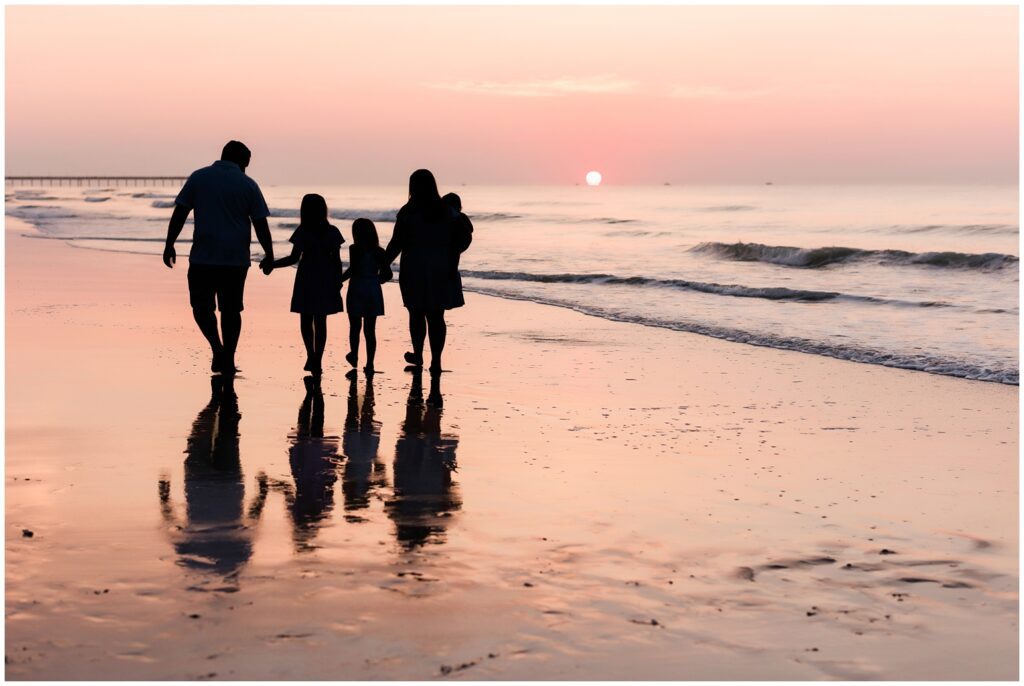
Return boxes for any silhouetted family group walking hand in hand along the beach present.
[164,140,473,384]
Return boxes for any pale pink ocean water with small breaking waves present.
[6,182,1020,384]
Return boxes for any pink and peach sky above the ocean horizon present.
[6,6,1018,183]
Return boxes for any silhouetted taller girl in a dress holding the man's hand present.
[263,194,345,377]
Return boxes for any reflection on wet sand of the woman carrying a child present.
[387,373,462,550]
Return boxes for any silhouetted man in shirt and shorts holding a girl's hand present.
[164,140,273,375]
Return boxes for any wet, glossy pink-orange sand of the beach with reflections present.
[5,218,1018,680]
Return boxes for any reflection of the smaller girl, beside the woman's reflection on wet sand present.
[341,374,387,521]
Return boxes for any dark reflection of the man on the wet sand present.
[160,377,267,580]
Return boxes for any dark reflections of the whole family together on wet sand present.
[159,370,462,591]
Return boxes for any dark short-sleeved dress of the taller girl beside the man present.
[289,224,345,314]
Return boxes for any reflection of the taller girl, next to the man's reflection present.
[274,377,338,551]
